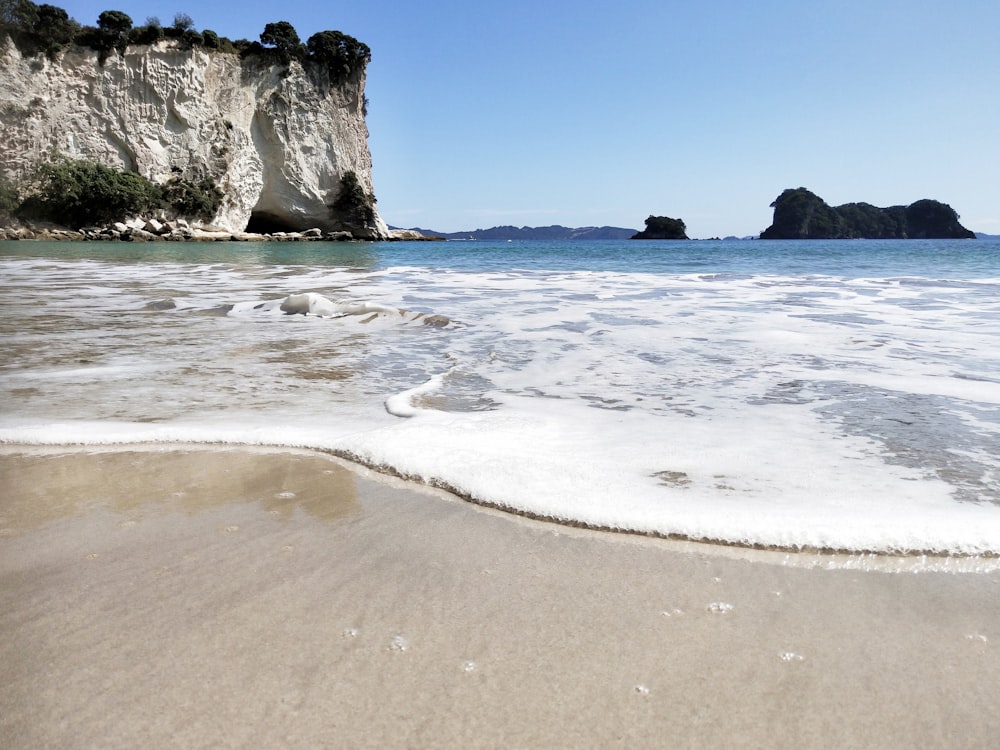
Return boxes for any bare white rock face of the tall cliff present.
[0,40,388,239]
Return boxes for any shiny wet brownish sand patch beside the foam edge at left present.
[0,446,360,536]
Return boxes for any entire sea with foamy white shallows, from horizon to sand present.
[0,240,1000,555]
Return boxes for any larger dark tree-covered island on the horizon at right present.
[760,187,975,240]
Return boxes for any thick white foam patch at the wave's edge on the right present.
[334,402,1000,554]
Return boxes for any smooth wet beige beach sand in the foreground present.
[0,446,1000,748]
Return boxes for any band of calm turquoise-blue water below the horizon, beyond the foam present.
[0,240,1000,278]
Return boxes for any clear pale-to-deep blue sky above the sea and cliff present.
[58,0,1000,237]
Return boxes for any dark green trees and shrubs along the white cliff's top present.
[0,0,371,86]
